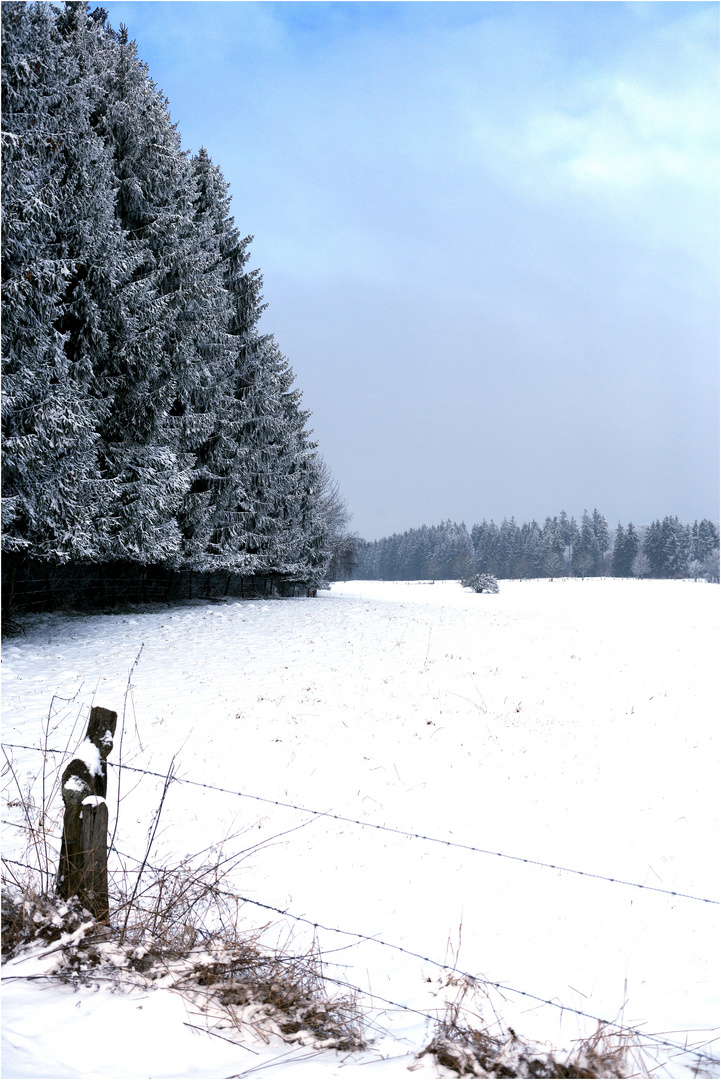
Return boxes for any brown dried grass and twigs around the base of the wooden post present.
[2,856,366,1051]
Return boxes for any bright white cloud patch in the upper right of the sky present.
[459,4,719,204]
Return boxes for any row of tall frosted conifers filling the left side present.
[2,2,343,581]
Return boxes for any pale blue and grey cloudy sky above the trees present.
[104,0,719,539]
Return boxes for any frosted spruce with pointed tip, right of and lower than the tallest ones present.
[172,149,266,571]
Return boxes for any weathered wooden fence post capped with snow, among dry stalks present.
[56,705,118,920]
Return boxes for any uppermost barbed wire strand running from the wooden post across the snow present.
[3,743,719,905]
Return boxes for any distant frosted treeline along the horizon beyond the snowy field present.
[354,510,719,581]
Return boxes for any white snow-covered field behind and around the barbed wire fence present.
[3,579,721,1080]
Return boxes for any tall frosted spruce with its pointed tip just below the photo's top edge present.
[91,27,203,563]
